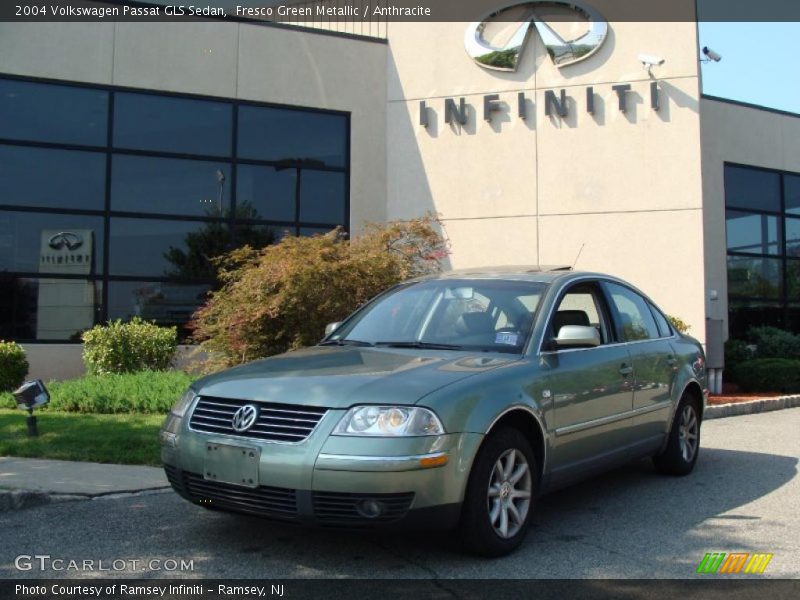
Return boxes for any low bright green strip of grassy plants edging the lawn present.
[0,371,193,414]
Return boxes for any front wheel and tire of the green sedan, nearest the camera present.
[459,428,539,556]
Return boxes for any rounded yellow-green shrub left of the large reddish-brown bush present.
[82,317,178,374]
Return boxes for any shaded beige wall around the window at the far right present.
[700,98,800,340]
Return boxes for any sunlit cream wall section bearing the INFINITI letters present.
[387,23,705,339]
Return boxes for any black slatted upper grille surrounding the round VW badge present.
[189,396,328,442]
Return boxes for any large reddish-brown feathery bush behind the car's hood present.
[192,216,447,370]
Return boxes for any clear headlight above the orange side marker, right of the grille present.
[333,406,444,437]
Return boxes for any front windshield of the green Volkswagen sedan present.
[323,279,546,353]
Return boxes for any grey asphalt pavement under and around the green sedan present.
[0,408,800,578]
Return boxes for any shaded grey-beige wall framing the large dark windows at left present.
[0,21,387,380]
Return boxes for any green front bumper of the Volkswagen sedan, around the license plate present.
[162,410,483,528]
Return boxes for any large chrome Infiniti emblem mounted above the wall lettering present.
[464,0,608,71]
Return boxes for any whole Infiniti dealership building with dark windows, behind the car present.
[0,3,800,378]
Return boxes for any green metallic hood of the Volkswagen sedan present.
[192,346,520,408]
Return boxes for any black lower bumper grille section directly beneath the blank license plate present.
[183,471,297,518]
